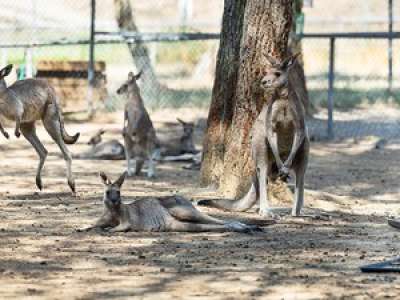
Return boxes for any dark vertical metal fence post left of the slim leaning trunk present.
[87,0,96,117]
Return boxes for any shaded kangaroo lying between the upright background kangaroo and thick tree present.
[160,118,199,157]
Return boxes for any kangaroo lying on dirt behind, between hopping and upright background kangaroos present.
[73,129,125,160]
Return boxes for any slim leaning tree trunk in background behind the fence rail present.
[114,0,161,102]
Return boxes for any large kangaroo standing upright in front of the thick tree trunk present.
[199,54,310,217]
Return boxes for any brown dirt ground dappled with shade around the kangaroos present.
[0,110,400,299]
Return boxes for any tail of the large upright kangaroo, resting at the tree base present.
[197,176,259,212]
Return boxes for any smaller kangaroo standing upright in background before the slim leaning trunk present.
[117,72,159,178]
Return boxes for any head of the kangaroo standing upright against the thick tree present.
[261,53,300,90]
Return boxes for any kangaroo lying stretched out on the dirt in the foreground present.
[83,172,261,232]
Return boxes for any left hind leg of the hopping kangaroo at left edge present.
[20,123,47,190]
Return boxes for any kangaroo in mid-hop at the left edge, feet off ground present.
[0,65,79,193]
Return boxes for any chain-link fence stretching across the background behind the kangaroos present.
[0,0,400,137]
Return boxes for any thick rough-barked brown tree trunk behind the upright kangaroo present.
[201,0,293,202]
